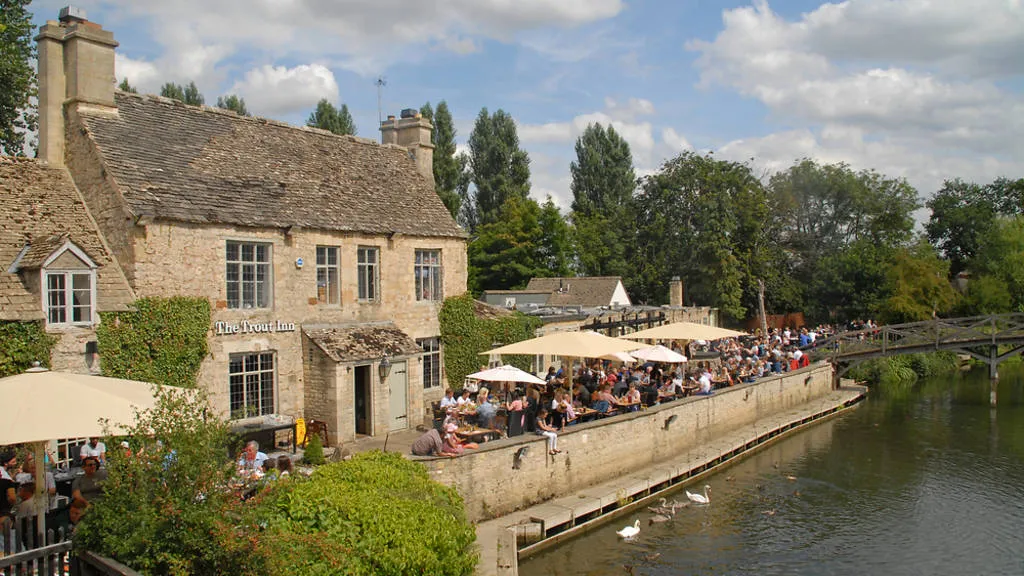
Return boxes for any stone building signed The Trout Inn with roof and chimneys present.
[20,11,466,441]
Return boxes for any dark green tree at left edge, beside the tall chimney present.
[0,0,37,156]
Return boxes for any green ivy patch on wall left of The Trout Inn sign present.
[96,296,210,387]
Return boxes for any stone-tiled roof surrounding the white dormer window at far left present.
[0,156,134,321]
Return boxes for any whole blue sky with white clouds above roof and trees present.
[31,0,1024,213]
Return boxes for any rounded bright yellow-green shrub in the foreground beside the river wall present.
[251,451,477,576]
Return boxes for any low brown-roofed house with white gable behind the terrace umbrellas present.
[481,276,632,308]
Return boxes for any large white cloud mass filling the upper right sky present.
[688,0,1024,194]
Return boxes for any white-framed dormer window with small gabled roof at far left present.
[9,236,98,328]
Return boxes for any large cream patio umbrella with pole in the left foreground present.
[0,366,186,542]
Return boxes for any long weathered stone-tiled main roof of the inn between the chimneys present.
[75,91,466,238]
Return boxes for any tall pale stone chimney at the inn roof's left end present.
[36,6,118,166]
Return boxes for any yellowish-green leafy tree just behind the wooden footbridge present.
[880,238,956,324]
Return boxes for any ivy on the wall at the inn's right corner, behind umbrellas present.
[438,292,542,388]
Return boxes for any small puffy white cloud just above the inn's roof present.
[230,64,338,116]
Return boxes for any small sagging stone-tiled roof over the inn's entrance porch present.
[302,322,423,362]
